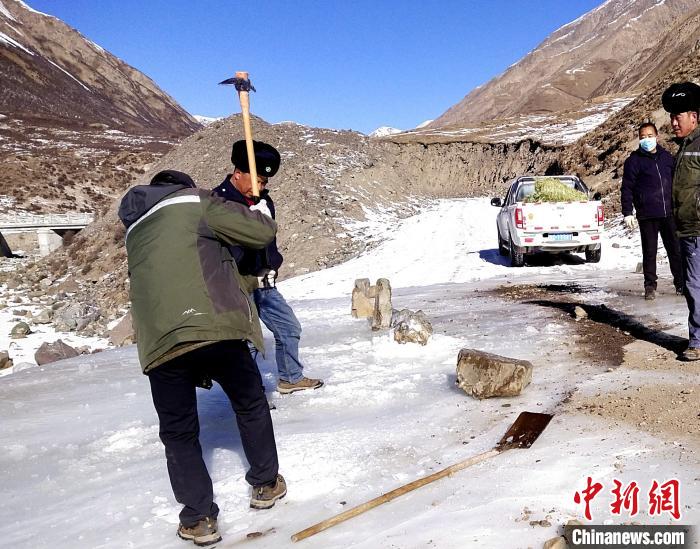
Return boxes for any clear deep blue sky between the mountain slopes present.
[27,0,601,133]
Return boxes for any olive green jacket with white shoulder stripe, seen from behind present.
[119,184,277,373]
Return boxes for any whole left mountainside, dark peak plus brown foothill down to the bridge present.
[0,0,201,213]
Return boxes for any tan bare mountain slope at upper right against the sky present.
[431,0,700,128]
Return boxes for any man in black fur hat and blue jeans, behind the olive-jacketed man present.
[212,140,323,394]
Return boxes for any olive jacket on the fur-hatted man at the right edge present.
[673,126,700,237]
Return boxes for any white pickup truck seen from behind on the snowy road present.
[491,175,604,267]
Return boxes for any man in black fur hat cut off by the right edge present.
[661,82,700,360]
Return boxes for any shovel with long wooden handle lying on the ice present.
[292,412,553,541]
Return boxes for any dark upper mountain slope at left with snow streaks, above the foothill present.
[0,0,199,137]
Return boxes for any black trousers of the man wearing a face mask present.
[639,217,683,290]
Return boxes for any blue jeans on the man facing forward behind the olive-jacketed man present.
[253,288,304,383]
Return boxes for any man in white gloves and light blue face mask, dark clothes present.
[620,122,683,300]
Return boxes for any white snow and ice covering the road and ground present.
[0,199,700,549]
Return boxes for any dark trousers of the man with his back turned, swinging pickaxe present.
[148,340,278,526]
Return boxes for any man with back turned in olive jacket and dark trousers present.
[119,170,287,545]
